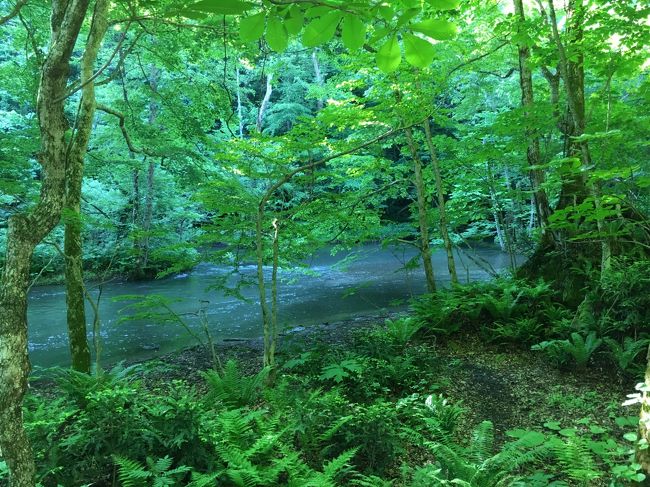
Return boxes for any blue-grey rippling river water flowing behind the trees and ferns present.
[28,245,508,366]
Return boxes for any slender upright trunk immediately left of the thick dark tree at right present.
[514,0,551,234]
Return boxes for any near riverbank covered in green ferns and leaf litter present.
[17,288,638,487]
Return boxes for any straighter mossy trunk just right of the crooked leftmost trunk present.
[64,0,108,373]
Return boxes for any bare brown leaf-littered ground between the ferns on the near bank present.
[142,313,638,441]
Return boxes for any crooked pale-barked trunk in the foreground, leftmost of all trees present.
[0,0,88,487]
